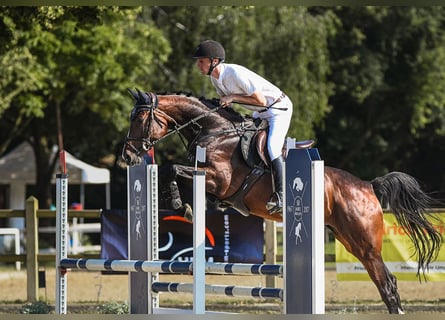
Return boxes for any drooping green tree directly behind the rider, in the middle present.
[152,6,335,161]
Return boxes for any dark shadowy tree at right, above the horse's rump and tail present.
[317,7,445,191]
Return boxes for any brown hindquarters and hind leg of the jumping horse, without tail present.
[325,167,403,313]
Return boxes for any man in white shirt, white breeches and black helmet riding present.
[193,40,293,214]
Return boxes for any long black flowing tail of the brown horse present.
[371,172,442,276]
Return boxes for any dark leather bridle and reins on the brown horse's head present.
[124,91,222,156]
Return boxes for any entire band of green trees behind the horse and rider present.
[0,6,445,205]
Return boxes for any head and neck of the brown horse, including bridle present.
[122,90,243,166]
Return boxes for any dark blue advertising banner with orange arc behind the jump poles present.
[101,210,264,263]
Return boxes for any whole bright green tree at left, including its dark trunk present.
[0,7,170,207]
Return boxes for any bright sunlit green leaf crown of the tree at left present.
[0,7,170,142]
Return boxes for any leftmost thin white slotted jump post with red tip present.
[55,150,68,314]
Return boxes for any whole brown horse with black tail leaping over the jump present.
[122,90,442,313]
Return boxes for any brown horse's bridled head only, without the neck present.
[122,89,171,166]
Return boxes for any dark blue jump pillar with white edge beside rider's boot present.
[283,138,325,314]
